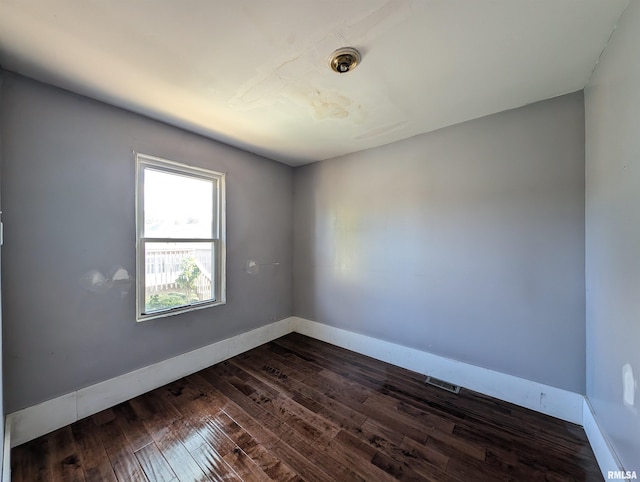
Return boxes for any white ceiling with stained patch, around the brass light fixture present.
[0,0,628,165]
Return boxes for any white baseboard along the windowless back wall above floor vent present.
[293,317,584,425]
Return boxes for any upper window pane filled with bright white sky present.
[143,167,214,239]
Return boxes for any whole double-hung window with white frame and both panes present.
[136,154,225,321]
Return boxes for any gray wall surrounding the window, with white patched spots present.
[0,73,293,412]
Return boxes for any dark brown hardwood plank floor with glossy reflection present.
[11,333,602,482]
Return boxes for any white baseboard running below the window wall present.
[7,318,293,447]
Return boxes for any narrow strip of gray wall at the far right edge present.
[585,2,640,471]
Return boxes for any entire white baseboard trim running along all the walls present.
[3,317,622,482]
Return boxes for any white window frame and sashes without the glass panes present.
[135,153,227,322]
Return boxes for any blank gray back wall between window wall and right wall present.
[294,93,585,393]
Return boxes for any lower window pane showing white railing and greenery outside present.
[144,242,216,313]
